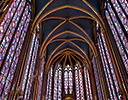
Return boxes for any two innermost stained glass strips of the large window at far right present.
[105,4,128,73]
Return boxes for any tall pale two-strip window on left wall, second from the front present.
[22,25,39,99]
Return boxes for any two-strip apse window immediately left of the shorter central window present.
[53,65,62,100]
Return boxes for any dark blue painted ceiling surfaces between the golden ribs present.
[35,0,100,65]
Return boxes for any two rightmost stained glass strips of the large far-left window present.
[0,7,30,98]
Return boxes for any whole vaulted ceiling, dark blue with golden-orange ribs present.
[35,0,100,70]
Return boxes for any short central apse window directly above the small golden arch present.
[64,65,73,94]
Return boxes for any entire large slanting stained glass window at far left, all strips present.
[0,0,31,99]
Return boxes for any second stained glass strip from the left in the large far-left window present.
[0,0,26,65]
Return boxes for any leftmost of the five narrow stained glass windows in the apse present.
[45,67,53,100]
